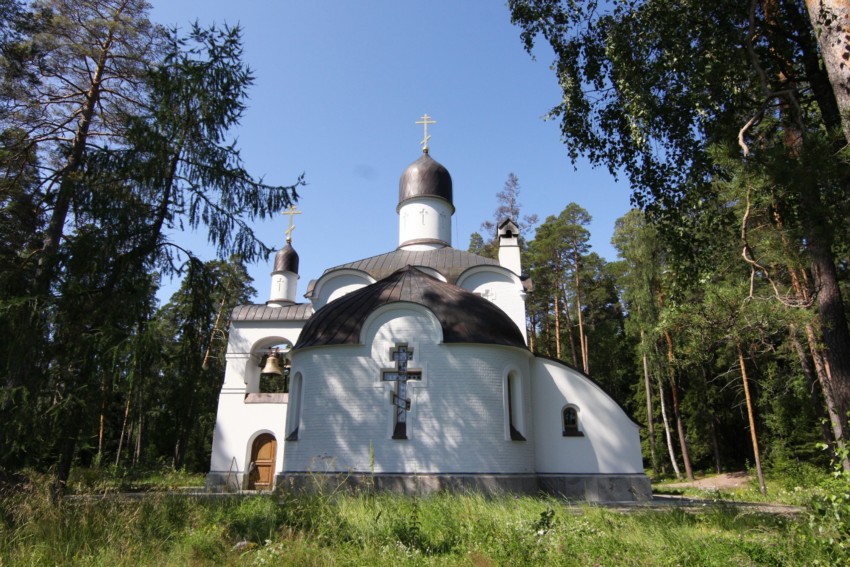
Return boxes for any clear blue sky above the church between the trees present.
[151,0,629,302]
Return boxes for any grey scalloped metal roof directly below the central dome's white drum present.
[325,246,499,283]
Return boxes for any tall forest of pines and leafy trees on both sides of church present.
[0,0,850,502]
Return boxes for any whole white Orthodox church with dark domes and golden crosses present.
[207,123,651,501]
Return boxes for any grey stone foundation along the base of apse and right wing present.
[275,472,652,502]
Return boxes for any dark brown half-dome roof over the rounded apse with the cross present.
[294,266,526,349]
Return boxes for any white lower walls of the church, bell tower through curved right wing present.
[210,282,643,486]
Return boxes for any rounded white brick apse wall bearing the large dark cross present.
[285,304,534,473]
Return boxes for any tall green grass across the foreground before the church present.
[0,468,831,567]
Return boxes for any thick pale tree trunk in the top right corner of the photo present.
[806,0,850,144]
